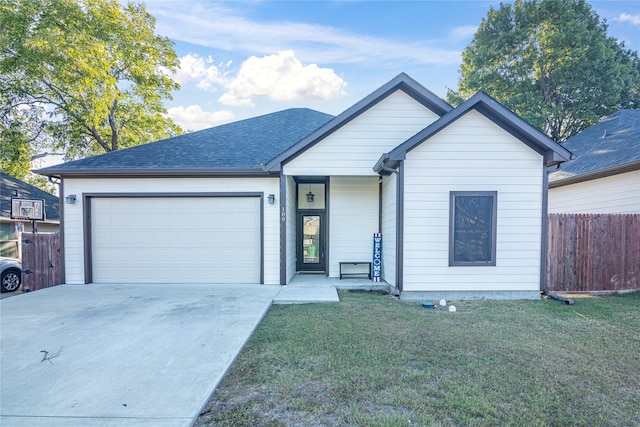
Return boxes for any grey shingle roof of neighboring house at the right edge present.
[549,110,640,187]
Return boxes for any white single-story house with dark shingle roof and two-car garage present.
[38,73,571,299]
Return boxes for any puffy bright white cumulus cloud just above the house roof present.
[218,50,346,105]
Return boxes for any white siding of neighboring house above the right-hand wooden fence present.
[549,170,640,214]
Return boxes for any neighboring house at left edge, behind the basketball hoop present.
[0,172,60,259]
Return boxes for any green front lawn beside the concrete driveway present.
[197,292,640,426]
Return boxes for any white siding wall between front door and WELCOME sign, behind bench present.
[329,176,378,277]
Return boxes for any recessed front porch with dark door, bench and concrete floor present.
[280,175,384,290]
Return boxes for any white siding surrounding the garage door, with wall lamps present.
[61,178,280,284]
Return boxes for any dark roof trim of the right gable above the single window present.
[374,92,571,173]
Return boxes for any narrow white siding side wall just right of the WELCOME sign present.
[382,174,398,286]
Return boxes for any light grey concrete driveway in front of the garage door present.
[0,284,282,427]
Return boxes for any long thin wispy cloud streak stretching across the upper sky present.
[147,1,460,67]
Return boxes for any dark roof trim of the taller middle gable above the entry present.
[266,73,453,171]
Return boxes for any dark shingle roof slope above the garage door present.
[38,108,333,176]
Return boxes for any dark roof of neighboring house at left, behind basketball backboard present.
[0,172,60,221]
